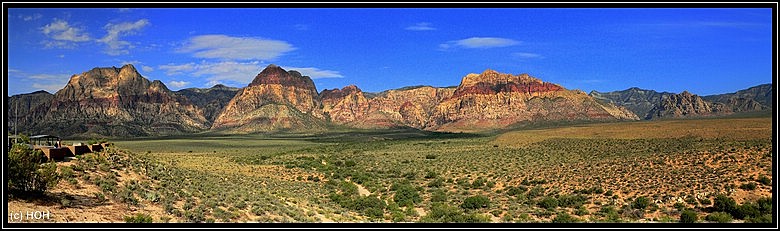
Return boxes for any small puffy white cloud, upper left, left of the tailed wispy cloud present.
[40,18,91,48]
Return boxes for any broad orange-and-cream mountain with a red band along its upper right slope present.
[426,70,638,131]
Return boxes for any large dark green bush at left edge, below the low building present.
[6,144,60,195]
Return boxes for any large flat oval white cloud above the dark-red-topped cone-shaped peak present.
[179,34,296,60]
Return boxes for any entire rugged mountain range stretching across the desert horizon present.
[6,64,773,137]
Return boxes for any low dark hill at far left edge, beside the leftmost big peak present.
[5,91,54,134]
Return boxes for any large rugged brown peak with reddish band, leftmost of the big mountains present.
[33,64,207,137]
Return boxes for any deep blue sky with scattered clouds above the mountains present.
[6,8,773,95]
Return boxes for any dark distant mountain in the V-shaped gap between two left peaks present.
[176,84,240,123]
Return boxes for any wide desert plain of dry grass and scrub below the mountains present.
[8,118,774,222]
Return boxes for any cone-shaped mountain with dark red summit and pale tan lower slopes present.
[211,64,325,133]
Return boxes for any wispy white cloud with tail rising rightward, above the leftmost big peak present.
[97,19,149,55]
